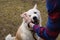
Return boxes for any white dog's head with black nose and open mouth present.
[26,4,40,24]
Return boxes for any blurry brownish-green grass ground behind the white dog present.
[0,0,59,40]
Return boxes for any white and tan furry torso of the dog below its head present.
[17,22,34,40]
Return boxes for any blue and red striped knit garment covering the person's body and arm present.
[33,0,60,40]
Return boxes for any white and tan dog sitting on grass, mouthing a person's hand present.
[5,5,41,40]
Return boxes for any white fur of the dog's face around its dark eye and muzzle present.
[26,4,42,26]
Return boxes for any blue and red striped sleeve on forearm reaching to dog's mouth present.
[33,25,58,40]
